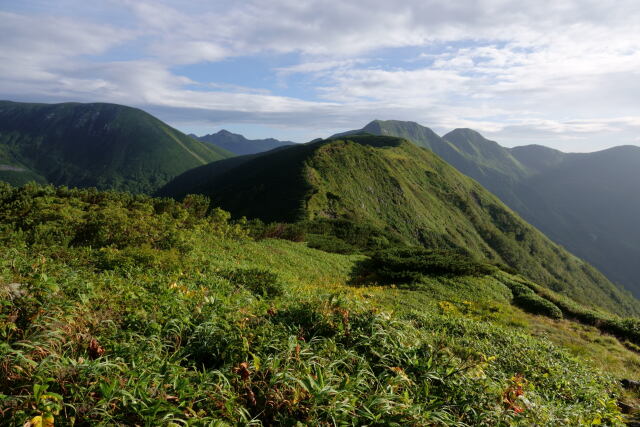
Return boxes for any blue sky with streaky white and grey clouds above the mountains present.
[0,0,640,152]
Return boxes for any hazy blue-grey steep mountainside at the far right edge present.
[518,146,640,295]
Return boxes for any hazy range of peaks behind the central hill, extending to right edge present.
[332,120,640,296]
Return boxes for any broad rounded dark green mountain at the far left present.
[0,101,232,193]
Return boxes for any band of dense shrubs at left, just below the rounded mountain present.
[0,185,247,251]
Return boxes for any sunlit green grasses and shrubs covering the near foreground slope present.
[0,185,640,426]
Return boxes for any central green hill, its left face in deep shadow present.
[161,135,639,313]
